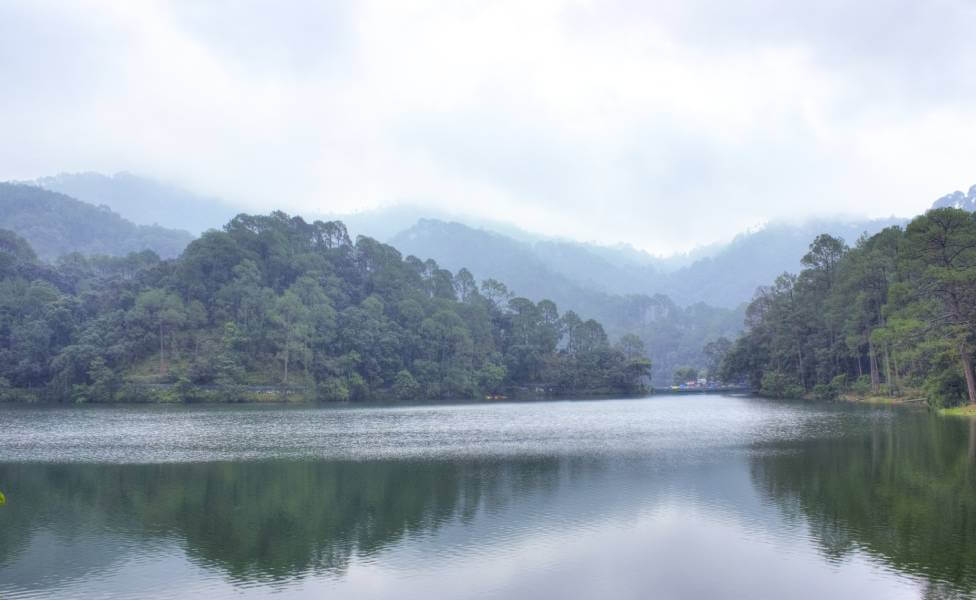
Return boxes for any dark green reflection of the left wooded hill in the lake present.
[0,459,576,579]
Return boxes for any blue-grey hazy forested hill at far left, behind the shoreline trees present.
[0,183,193,261]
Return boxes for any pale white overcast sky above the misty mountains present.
[0,0,976,253]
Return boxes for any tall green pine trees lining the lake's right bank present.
[721,208,976,406]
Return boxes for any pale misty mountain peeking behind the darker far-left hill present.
[28,172,241,234]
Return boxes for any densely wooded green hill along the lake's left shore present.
[0,212,650,401]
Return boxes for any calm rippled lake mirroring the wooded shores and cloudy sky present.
[0,396,976,600]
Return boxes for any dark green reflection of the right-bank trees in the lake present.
[752,414,976,597]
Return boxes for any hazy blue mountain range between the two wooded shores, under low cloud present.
[389,218,904,308]
